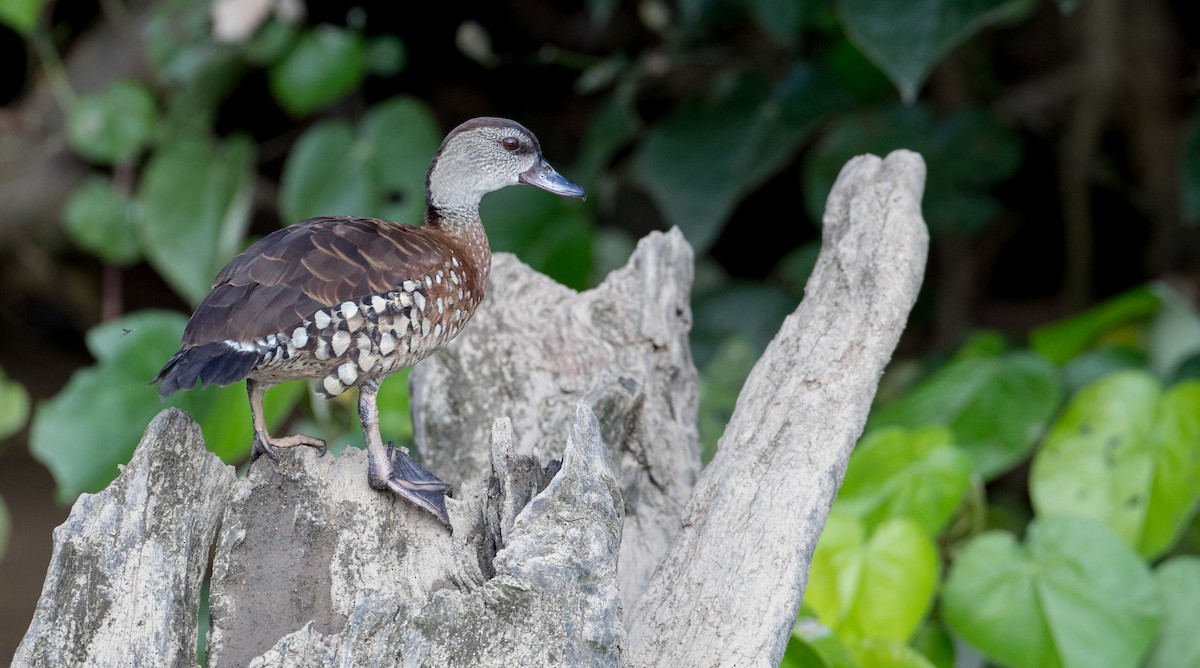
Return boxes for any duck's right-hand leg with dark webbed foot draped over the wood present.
[359,380,450,528]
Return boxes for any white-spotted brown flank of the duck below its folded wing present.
[239,249,484,397]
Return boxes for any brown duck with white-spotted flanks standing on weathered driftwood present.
[151,116,586,529]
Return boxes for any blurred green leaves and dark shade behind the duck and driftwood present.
[0,0,1200,667]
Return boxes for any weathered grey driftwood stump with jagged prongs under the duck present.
[14,151,928,667]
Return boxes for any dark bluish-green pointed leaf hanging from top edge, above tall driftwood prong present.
[838,0,1014,103]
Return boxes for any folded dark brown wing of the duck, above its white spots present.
[182,217,450,348]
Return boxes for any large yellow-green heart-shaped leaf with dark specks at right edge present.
[1030,371,1200,556]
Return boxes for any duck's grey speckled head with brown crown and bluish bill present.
[425,116,586,211]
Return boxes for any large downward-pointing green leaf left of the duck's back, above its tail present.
[138,136,254,305]
